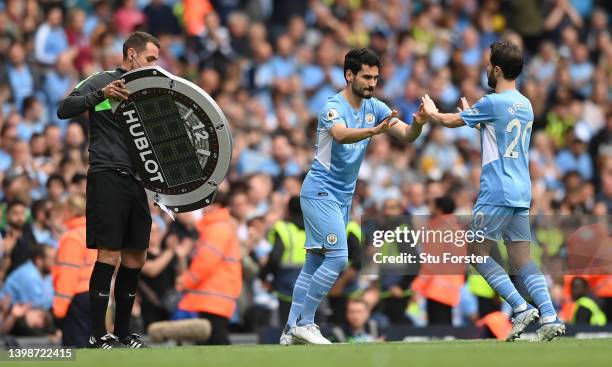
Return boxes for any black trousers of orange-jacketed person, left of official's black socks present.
[62,292,91,348]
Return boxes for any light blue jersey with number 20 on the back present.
[461,90,533,208]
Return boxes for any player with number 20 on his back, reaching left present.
[423,42,565,341]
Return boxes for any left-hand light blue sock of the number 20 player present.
[475,256,527,312]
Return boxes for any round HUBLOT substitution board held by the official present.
[111,66,232,213]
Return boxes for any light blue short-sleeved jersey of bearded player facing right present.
[301,93,391,205]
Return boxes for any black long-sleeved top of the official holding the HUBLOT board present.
[57,68,134,174]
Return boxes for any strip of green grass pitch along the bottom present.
[8,338,612,367]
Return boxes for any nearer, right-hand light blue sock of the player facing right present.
[298,253,348,326]
